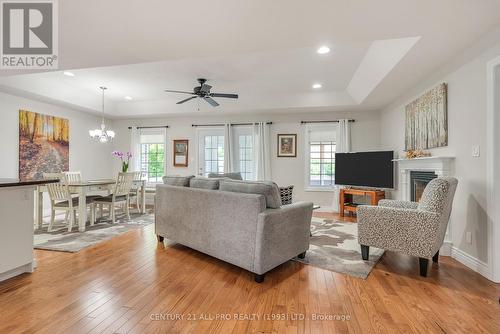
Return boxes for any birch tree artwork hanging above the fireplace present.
[405,83,448,151]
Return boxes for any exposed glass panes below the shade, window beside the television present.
[309,141,335,187]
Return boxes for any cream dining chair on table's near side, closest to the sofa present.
[92,172,135,224]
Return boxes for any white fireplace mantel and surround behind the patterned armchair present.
[393,156,455,256]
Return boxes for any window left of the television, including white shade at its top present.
[305,124,337,189]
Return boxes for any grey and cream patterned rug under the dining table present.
[34,212,154,253]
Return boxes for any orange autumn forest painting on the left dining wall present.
[19,110,69,180]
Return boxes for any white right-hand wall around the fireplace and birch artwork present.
[381,40,500,275]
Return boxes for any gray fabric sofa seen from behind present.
[155,178,313,283]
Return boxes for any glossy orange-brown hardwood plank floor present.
[0,213,500,334]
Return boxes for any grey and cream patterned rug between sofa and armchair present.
[294,217,384,279]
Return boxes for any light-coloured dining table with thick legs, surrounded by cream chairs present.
[35,179,146,232]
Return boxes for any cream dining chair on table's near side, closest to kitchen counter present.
[43,173,95,232]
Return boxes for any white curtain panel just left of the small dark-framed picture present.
[253,122,272,180]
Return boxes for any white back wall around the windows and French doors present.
[114,110,380,207]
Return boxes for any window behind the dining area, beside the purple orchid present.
[140,129,166,183]
